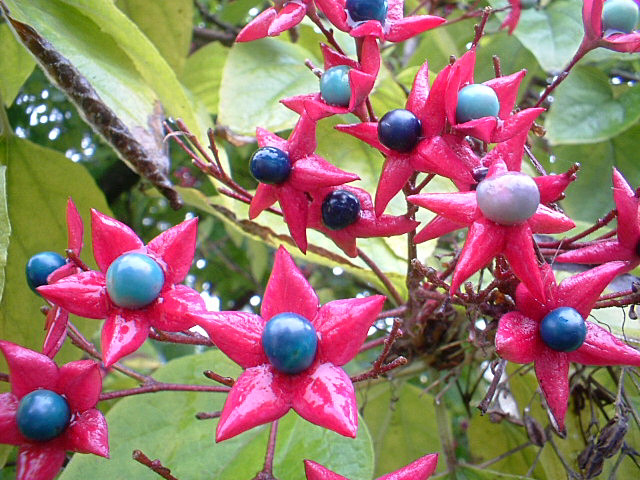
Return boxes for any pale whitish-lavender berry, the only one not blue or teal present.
[476,172,540,225]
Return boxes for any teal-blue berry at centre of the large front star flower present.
[262,312,318,374]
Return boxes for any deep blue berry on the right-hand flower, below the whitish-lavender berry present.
[540,307,587,352]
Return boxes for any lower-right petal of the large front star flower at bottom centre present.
[291,363,358,438]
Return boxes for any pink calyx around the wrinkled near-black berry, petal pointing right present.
[308,185,420,258]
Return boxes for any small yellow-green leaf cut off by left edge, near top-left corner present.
[0,23,36,107]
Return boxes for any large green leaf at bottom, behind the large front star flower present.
[60,350,373,480]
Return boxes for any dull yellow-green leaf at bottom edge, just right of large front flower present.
[358,382,446,476]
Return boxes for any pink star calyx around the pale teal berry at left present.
[38,210,204,366]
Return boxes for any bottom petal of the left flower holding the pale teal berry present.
[101,309,149,367]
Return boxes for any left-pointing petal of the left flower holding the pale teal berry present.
[36,270,109,318]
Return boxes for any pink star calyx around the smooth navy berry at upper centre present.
[336,62,473,216]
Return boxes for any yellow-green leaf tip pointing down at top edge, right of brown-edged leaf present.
[116,0,194,75]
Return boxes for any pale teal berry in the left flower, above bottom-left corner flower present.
[107,253,164,309]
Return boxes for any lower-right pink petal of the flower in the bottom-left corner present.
[63,408,109,458]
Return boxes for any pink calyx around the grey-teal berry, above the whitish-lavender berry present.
[439,48,544,143]
